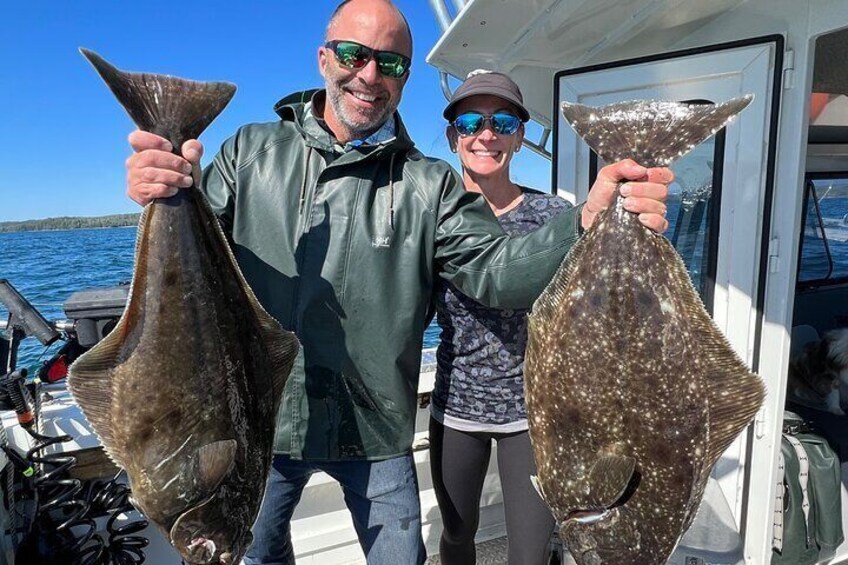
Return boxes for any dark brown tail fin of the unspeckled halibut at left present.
[80,48,236,154]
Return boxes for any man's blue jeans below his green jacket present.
[244,455,427,565]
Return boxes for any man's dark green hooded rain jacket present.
[202,91,579,460]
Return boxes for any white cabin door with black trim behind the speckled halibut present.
[553,36,783,563]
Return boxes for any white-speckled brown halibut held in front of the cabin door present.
[524,96,765,565]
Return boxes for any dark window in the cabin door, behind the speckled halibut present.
[590,100,725,311]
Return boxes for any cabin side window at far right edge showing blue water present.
[798,173,848,287]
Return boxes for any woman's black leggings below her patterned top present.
[430,418,555,565]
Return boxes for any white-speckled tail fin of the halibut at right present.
[561,94,754,167]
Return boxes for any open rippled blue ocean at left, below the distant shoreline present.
[0,227,439,368]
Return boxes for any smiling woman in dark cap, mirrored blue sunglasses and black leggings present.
[430,71,569,565]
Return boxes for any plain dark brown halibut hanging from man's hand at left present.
[68,50,298,563]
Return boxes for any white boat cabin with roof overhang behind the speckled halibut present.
[428,0,848,565]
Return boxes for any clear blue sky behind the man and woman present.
[0,0,550,221]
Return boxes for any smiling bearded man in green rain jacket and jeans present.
[127,0,673,564]
